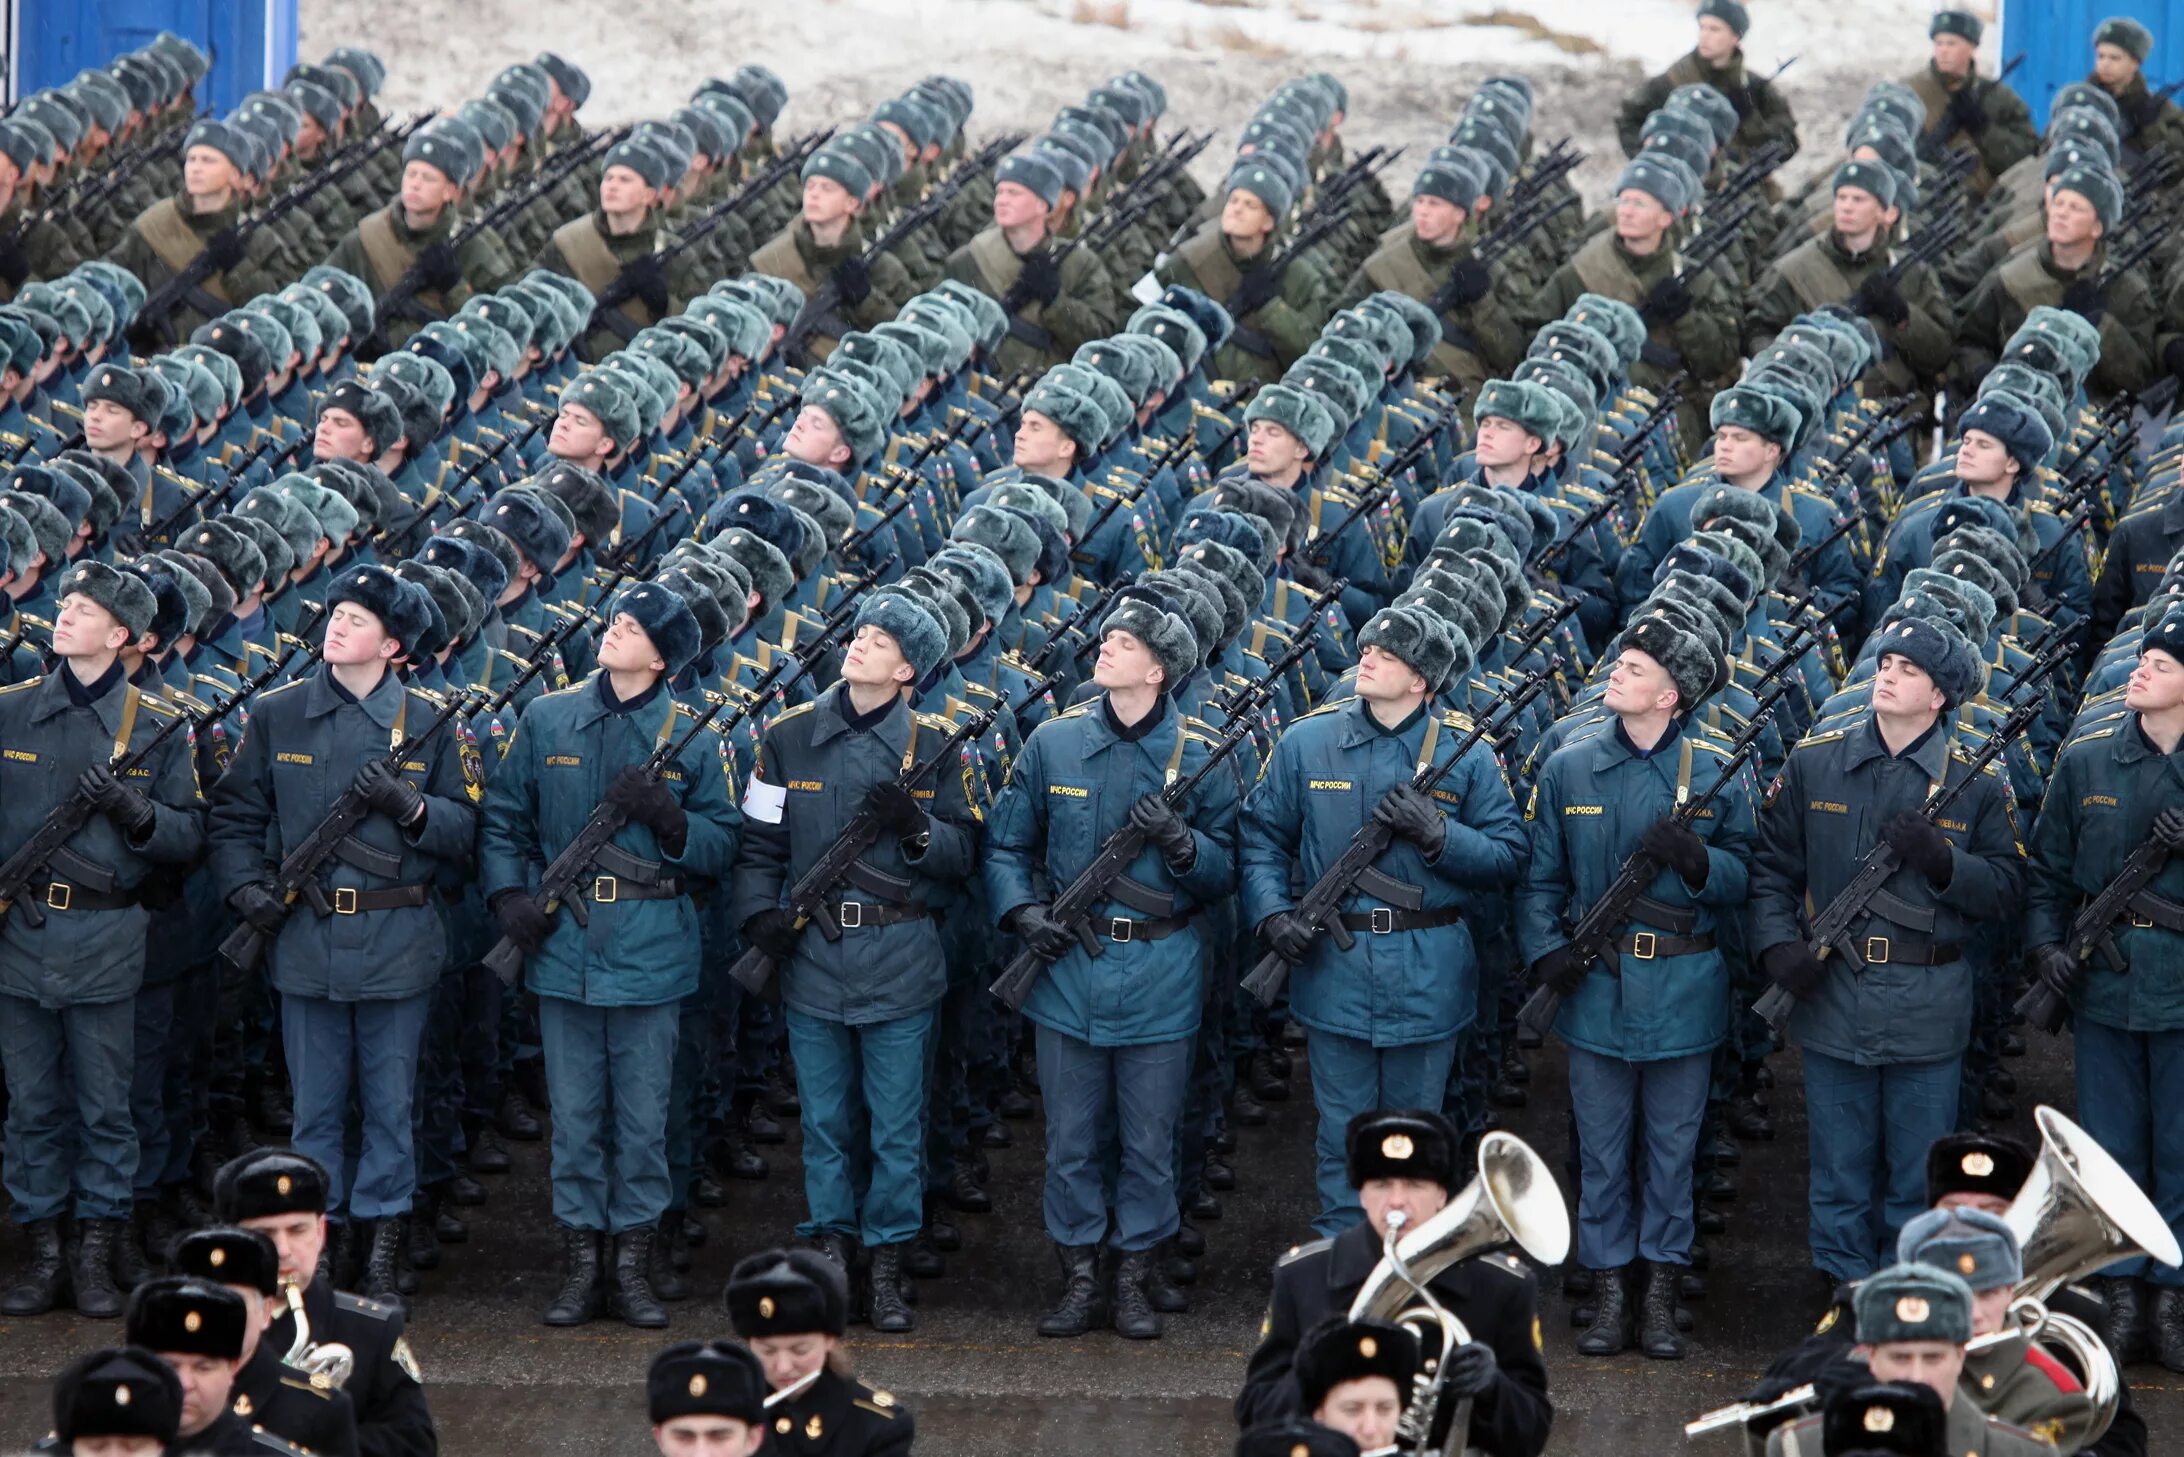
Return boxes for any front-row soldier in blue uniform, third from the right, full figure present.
[1516,614,1754,1361]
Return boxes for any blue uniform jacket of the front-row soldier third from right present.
[1516,719,1756,1062]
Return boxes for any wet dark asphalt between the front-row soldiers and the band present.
[0,1040,2184,1457]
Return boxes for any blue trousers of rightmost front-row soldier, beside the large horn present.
[2077,1016,2184,1287]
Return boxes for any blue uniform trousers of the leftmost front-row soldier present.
[0,996,138,1223]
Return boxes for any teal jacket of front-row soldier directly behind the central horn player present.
[1243,699,1524,1046]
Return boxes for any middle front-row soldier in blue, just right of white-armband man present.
[985,590,1238,1339]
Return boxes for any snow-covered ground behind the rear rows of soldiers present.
[301,0,1998,207]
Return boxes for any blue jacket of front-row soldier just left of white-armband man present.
[478,673,743,1007]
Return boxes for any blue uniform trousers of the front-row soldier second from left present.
[282,990,432,1219]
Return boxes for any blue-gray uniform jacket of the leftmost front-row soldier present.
[0,664,205,1007]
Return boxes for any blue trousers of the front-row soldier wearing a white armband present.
[784,1007,939,1245]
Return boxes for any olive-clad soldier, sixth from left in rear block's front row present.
[948,151,1120,378]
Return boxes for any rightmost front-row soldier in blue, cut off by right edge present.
[2025,616,2184,1370]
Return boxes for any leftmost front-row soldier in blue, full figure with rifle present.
[0,561,205,1319]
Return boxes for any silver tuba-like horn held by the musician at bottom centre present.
[1350,1134,1570,1457]
